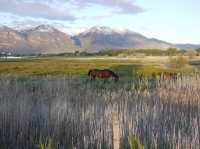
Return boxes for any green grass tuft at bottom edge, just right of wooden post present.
[128,135,143,149]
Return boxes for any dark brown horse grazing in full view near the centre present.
[88,69,119,82]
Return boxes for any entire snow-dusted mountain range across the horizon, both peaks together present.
[0,25,200,54]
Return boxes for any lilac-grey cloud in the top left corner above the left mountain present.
[0,0,76,21]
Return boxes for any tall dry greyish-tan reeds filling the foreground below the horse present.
[0,76,200,149]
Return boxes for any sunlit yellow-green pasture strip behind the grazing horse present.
[0,57,194,76]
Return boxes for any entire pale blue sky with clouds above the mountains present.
[0,0,200,44]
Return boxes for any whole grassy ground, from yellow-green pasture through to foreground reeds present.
[0,57,200,149]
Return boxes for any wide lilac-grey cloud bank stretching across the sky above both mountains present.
[0,0,143,23]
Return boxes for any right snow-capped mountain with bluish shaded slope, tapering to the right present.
[75,27,173,52]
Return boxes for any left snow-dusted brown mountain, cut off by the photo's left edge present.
[0,25,78,54]
